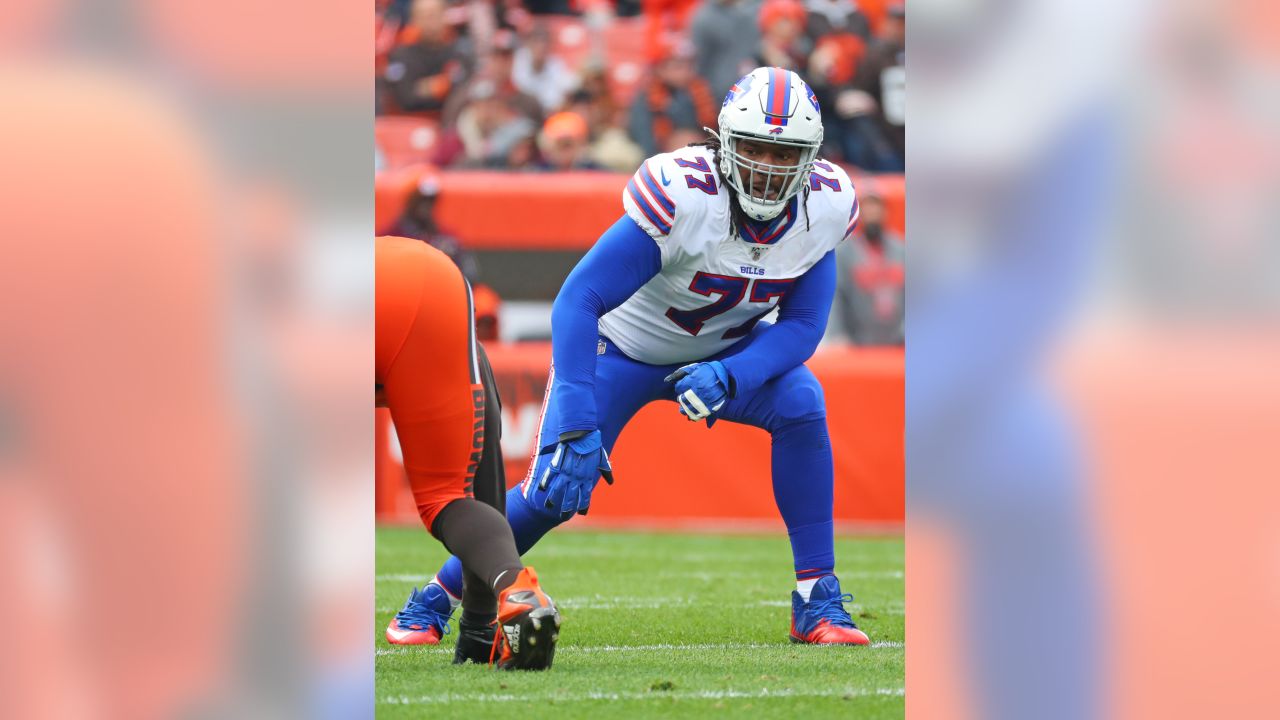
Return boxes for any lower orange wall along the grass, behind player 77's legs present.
[375,343,904,529]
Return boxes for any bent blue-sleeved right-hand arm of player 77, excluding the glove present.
[722,251,836,395]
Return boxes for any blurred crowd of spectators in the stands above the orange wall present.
[376,0,905,173]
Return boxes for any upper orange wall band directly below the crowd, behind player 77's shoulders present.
[374,167,906,251]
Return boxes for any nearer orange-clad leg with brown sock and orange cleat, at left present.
[375,238,559,669]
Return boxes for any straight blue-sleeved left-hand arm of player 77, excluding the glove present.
[552,215,662,436]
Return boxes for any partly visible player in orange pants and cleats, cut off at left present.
[375,237,561,670]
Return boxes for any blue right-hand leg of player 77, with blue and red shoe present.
[719,365,868,644]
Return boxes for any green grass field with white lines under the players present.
[376,520,904,720]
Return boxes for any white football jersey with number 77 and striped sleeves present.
[600,147,858,365]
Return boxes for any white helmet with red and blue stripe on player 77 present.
[719,68,822,220]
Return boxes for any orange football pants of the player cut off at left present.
[374,237,485,530]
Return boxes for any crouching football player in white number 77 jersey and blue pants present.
[386,68,869,644]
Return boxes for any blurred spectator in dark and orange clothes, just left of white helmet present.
[627,41,721,156]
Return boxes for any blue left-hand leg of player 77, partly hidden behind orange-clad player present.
[431,342,669,614]
